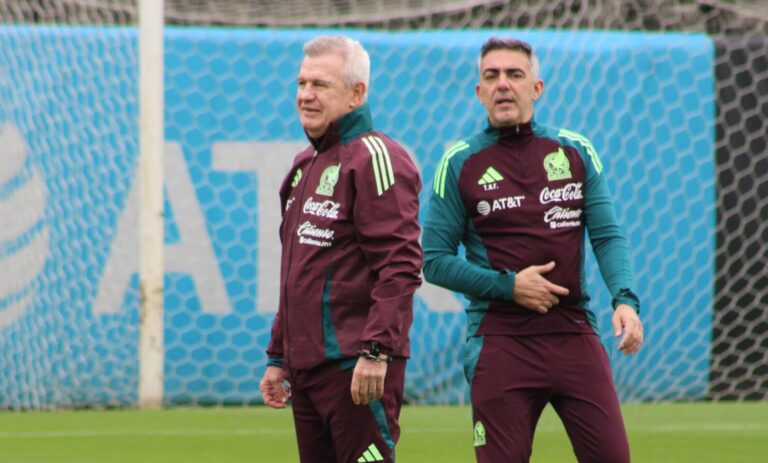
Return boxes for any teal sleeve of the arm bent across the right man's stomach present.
[422,142,515,300]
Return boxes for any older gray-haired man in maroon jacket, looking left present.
[260,36,422,463]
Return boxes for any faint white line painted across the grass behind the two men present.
[0,423,768,439]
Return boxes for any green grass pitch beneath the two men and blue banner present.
[0,402,768,463]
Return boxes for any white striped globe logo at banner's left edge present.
[0,123,50,329]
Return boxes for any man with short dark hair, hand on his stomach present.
[423,38,643,463]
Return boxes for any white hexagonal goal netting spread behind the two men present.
[0,0,768,408]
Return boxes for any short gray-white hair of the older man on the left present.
[304,35,371,99]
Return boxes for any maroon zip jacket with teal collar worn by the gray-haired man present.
[267,105,422,370]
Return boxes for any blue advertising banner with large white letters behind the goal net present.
[0,26,715,408]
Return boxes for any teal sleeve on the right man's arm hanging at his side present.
[558,130,640,311]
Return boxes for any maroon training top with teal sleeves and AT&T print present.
[423,121,639,336]
